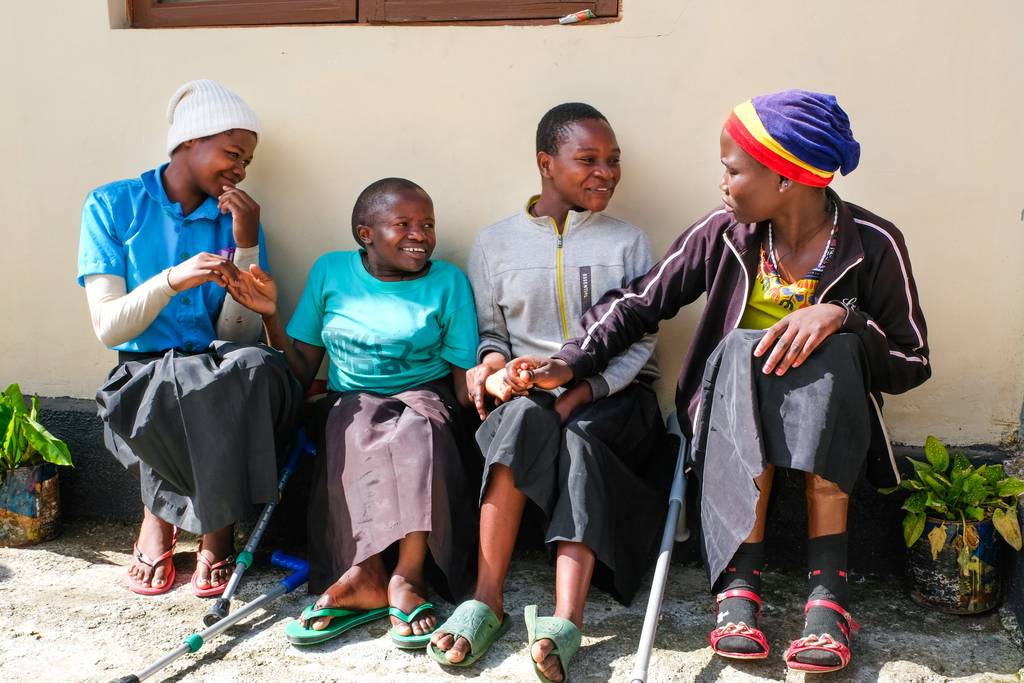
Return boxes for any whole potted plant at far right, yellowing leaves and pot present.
[882,436,1024,614]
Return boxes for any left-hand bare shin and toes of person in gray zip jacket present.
[431,465,526,664]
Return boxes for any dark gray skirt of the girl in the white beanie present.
[96,341,302,533]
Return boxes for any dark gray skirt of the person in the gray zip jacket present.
[476,382,675,603]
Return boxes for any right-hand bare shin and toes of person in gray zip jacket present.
[529,541,596,683]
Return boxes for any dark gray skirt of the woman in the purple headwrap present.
[693,330,872,586]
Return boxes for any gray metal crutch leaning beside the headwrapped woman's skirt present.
[630,413,690,683]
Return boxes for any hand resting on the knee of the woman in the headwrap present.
[754,303,846,377]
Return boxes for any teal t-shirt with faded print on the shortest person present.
[288,251,478,395]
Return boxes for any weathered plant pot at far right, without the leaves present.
[906,517,1004,614]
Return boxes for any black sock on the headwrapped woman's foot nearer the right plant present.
[797,532,850,667]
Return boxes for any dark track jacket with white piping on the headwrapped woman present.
[555,190,932,479]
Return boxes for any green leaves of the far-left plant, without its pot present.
[0,384,71,476]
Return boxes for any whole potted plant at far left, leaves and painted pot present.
[0,384,71,546]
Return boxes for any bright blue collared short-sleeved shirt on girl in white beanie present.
[78,164,267,352]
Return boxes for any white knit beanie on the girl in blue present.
[167,79,259,157]
